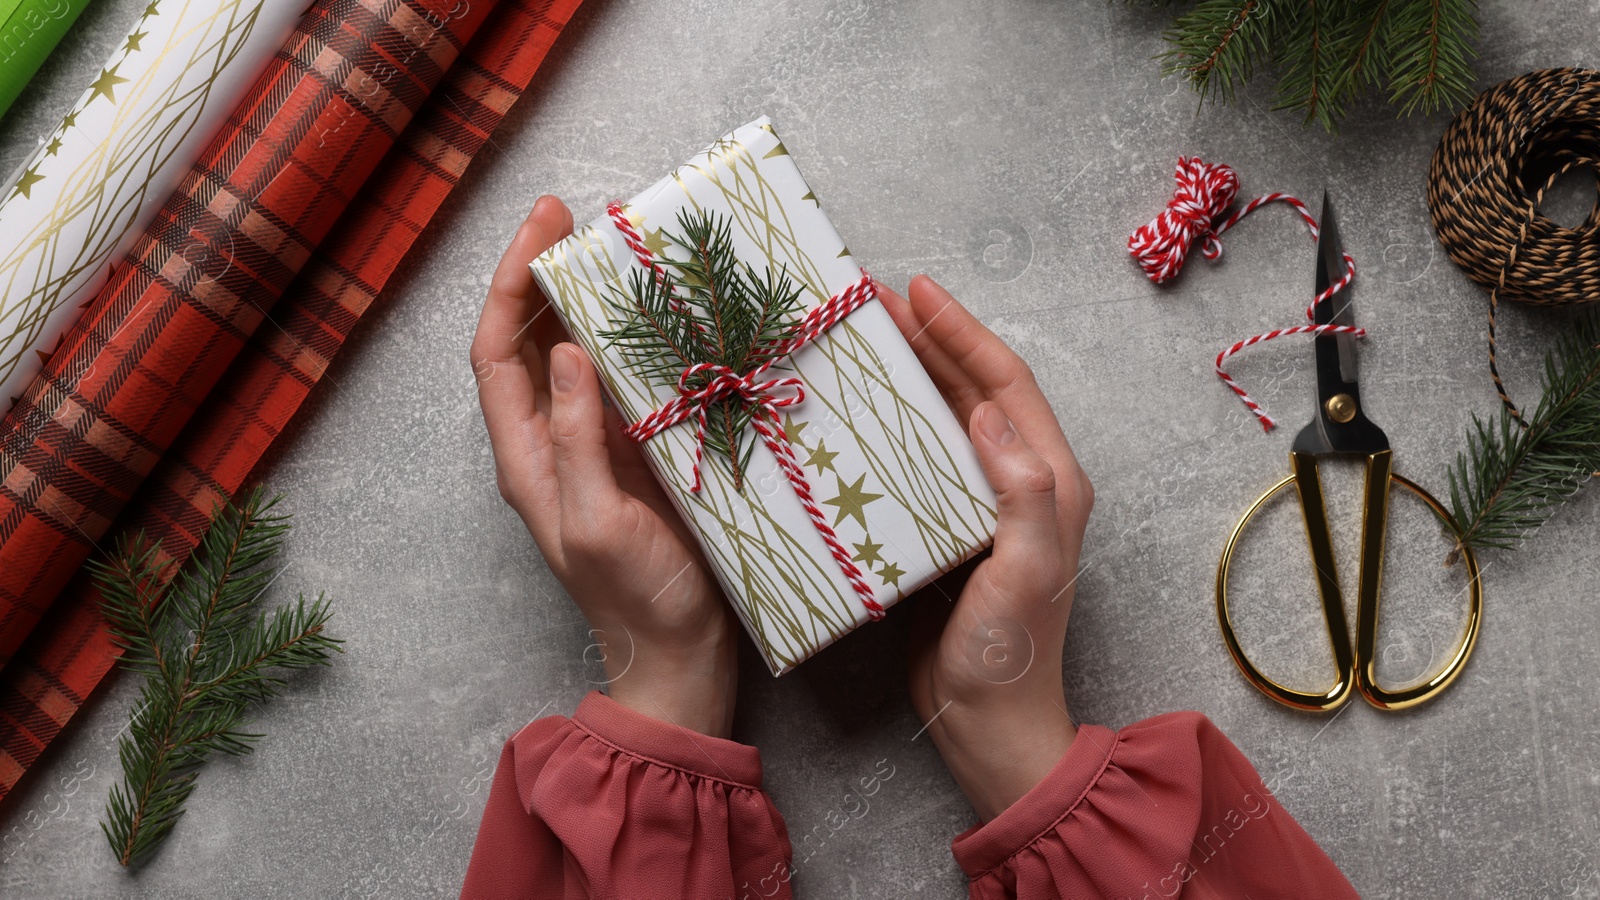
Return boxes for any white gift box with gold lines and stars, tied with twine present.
[531,117,995,674]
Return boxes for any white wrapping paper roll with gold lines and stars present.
[0,0,309,403]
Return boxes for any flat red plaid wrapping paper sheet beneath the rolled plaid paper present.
[0,0,581,798]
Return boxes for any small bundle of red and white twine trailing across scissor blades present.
[1128,157,1366,431]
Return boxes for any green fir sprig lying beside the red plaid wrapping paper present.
[90,490,341,865]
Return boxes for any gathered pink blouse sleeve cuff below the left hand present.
[461,693,790,900]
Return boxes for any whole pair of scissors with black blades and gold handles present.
[1216,194,1483,711]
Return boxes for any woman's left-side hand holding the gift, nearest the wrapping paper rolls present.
[472,197,738,737]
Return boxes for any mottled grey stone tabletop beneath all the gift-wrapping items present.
[0,0,1600,898]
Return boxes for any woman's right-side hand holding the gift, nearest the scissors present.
[880,275,1094,822]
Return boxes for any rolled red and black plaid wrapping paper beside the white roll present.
[0,0,493,663]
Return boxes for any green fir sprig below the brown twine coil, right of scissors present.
[1450,317,1600,559]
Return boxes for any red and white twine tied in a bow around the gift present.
[606,202,883,618]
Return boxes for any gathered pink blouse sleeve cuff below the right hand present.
[950,713,1357,900]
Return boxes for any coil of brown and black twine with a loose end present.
[1427,69,1600,421]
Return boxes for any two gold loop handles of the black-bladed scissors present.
[1216,450,1483,711]
